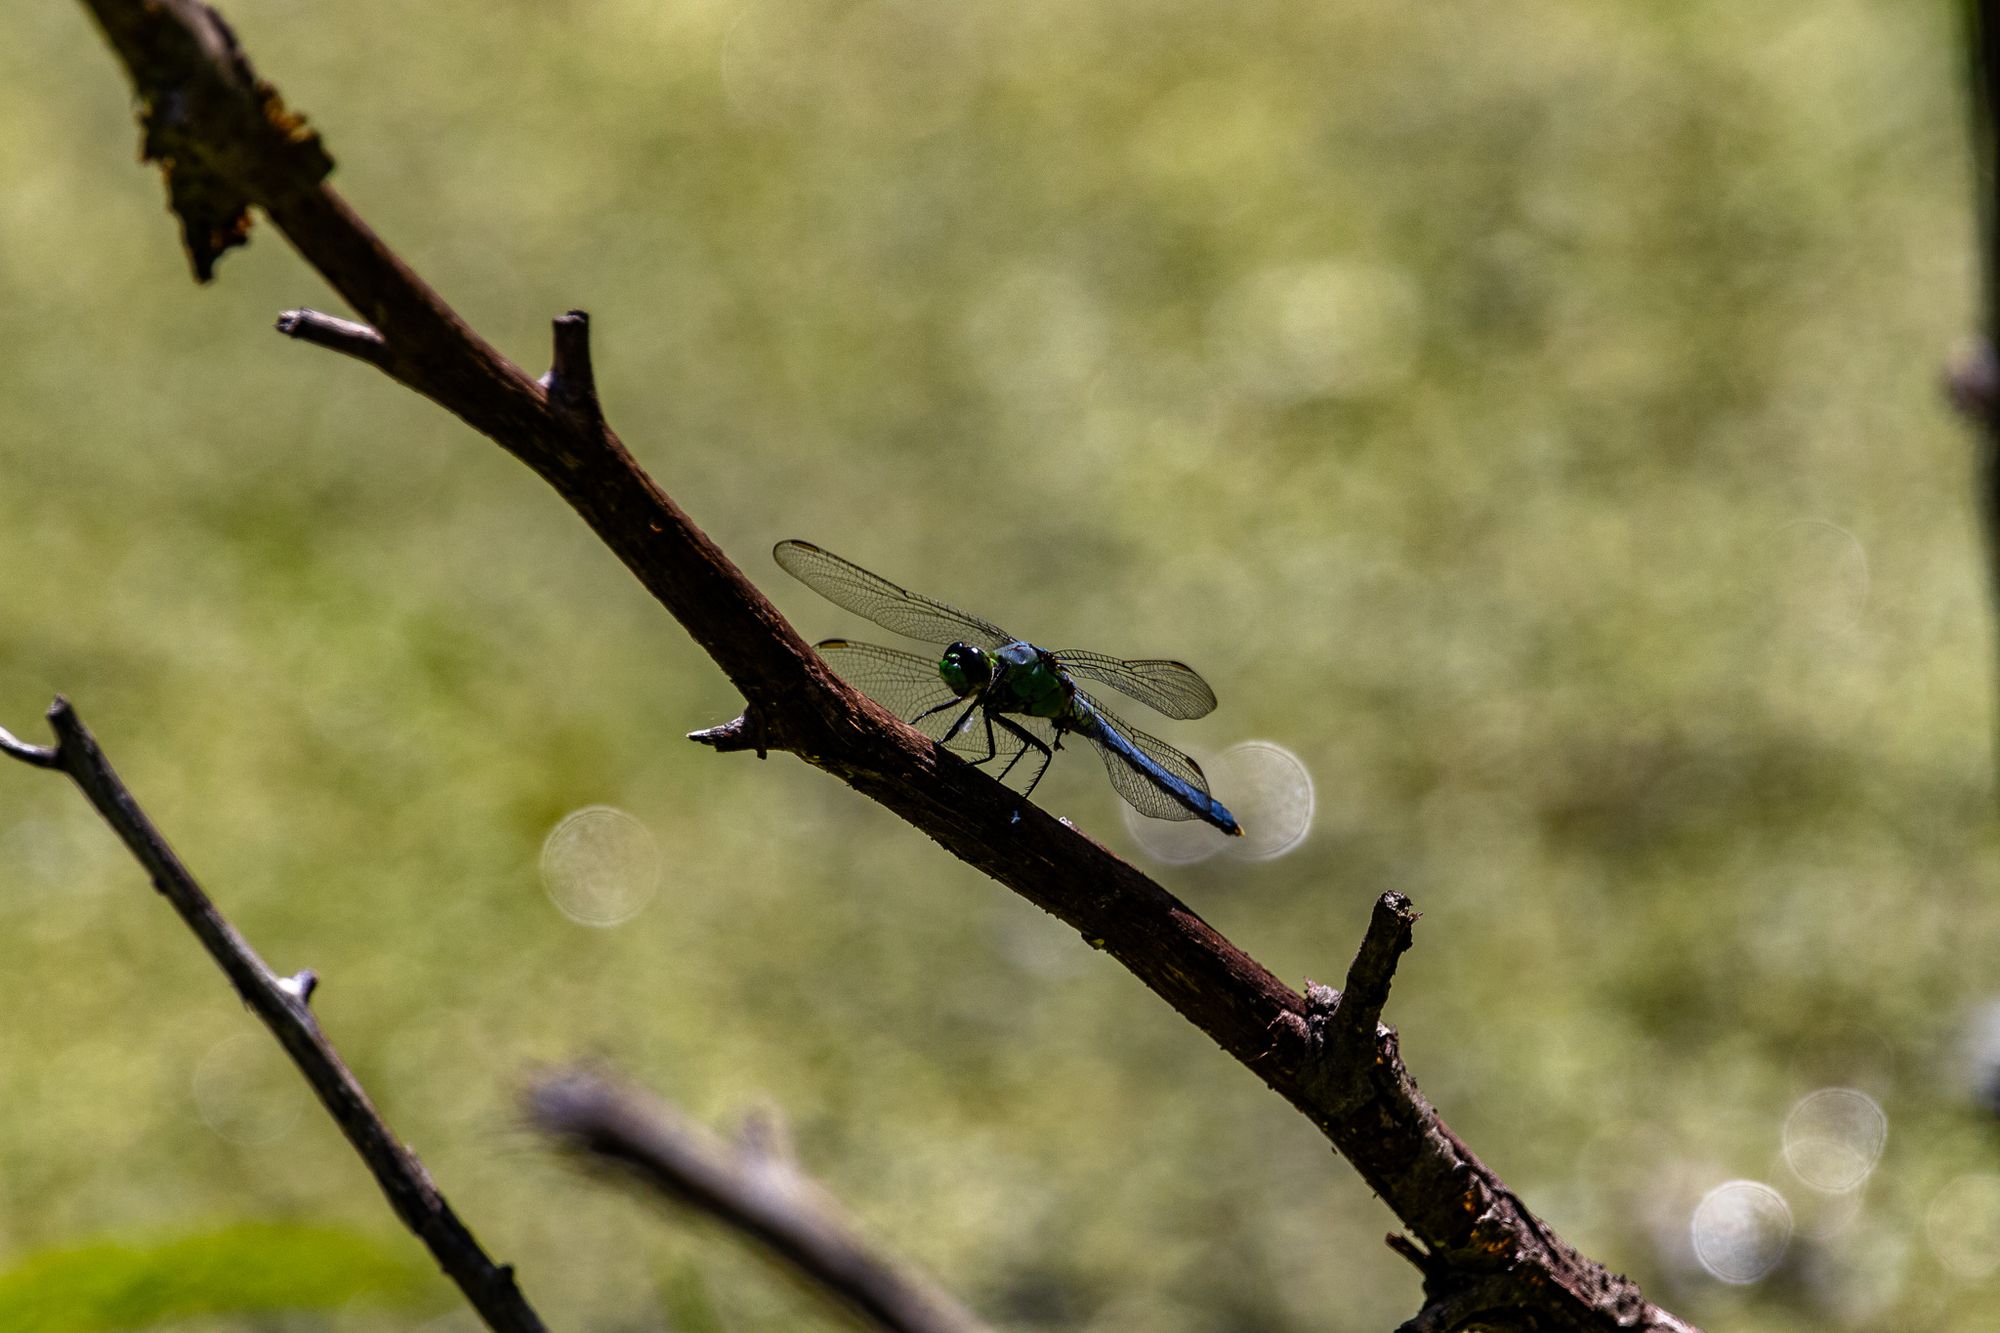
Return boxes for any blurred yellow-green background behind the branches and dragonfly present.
[0,0,2000,1333]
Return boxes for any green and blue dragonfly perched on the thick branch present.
[772,540,1242,837]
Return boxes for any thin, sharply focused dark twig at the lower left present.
[0,699,544,1333]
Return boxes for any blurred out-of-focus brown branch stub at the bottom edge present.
[524,1071,986,1333]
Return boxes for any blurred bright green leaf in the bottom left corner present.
[0,1223,438,1333]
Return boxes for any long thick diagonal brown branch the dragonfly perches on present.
[62,0,1688,1329]
